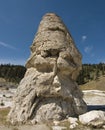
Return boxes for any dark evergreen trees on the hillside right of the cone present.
[77,63,105,85]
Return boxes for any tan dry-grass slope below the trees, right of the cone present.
[80,77,105,91]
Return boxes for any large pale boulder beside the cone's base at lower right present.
[79,110,105,127]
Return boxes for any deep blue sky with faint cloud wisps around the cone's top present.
[0,0,105,65]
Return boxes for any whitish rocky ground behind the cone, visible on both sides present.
[0,88,105,110]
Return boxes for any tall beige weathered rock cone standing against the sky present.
[8,13,87,123]
